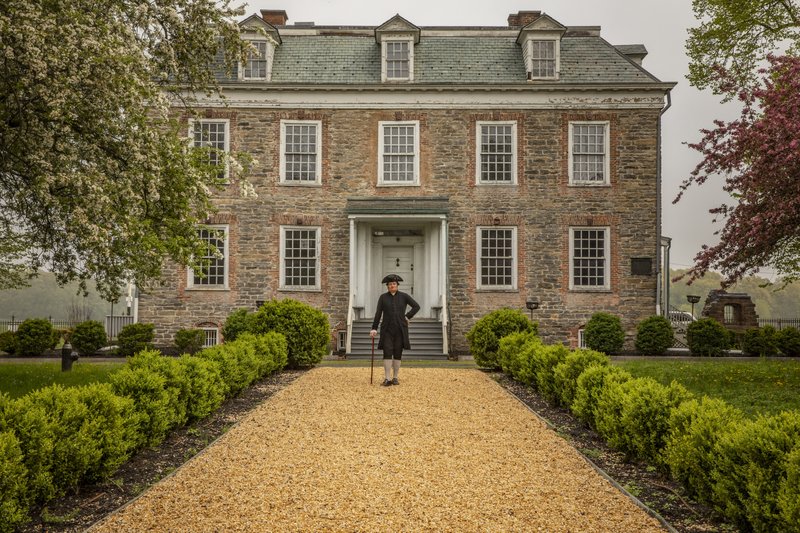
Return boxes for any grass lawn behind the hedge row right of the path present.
[614,359,800,416]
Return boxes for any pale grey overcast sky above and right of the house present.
[246,0,744,274]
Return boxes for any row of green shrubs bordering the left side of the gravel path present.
[0,332,288,532]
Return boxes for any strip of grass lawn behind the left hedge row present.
[0,361,125,398]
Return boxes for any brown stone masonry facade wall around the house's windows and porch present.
[139,105,659,354]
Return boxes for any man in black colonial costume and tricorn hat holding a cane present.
[369,274,419,387]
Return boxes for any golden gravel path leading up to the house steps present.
[91,367,664,533]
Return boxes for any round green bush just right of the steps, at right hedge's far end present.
[467,308,538,368]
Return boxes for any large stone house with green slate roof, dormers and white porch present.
[138,10,675,356]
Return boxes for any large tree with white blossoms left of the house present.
[0,0,247,298]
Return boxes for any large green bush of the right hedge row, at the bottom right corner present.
[713,411,800,531]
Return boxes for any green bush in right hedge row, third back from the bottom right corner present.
[595,378,691,464]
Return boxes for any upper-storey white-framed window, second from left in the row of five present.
[280,120,322,185]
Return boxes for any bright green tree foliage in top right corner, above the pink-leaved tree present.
[686,0,800,94]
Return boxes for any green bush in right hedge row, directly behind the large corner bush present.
[663,396,744,503]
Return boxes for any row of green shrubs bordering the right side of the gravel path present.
[498,333,800,532]
